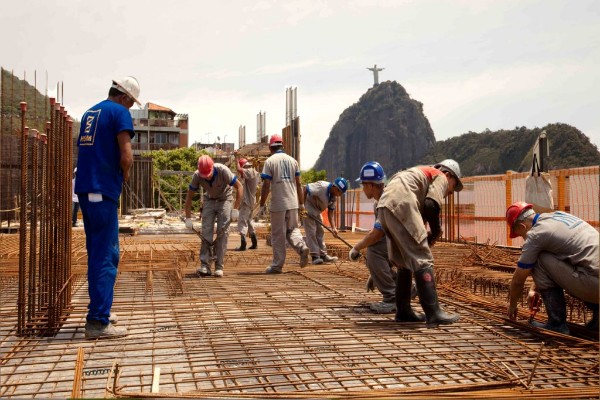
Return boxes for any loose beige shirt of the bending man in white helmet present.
[377,166,448,243]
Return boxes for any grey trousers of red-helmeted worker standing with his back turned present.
[271,208,306,270]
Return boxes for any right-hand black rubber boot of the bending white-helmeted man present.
[415,267,460,328]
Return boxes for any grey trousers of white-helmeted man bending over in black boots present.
[377,208,433,274]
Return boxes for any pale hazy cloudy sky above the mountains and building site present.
[0,0,600,170]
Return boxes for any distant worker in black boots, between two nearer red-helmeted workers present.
[233,151,260,251]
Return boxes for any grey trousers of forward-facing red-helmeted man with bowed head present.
[200,200,233,269]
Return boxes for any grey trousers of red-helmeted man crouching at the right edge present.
[532,252,599,304]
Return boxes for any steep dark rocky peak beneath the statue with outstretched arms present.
[313,81,436,186]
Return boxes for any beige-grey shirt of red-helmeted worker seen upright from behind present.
[260,151,300,212]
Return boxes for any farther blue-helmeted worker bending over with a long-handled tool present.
[302,177,348,265]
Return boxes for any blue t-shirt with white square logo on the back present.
[75,100,135,201]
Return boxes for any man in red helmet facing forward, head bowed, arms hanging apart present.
[185,155,243,278]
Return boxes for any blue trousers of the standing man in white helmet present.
[79,194,119,325]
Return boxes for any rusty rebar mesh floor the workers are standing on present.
[0,238,600,398]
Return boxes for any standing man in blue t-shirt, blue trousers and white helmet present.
[75,76,140,339]
